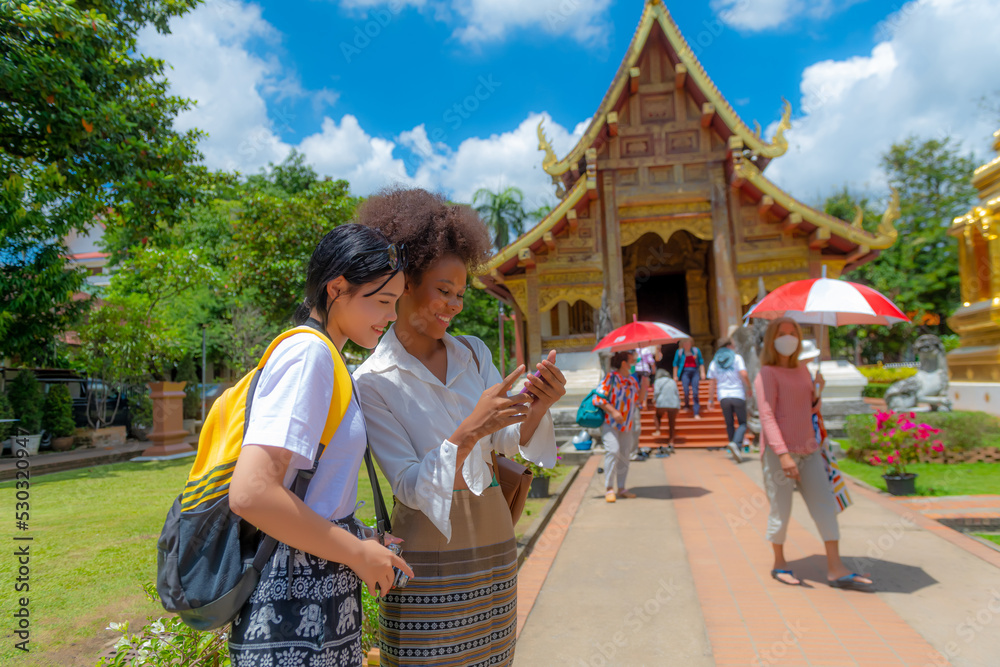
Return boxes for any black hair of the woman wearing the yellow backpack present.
[293,223,396,329]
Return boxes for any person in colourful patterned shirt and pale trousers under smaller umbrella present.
[594,351,639,503]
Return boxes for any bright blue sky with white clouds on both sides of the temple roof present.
[140,0,1000,209]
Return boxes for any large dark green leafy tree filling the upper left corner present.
[0,0,206,362]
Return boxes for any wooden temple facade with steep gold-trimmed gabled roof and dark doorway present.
[479,0,898,366]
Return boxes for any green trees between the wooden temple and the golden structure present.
[825,137,976,361]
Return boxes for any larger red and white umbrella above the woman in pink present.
[747,278,910,326]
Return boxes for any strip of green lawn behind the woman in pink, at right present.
[839,459,1000,496]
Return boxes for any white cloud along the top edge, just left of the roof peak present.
[341,0,611,45]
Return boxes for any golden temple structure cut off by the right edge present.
[948,130,1000,414]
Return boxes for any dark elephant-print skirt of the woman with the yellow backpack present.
[229,514,364,667]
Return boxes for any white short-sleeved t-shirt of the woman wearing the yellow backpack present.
[243,333,367,520]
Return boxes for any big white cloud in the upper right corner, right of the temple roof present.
[767,0,1000,203]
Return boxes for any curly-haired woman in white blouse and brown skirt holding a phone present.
[355,189,566,667]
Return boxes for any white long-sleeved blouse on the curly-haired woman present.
[354,326,556,541]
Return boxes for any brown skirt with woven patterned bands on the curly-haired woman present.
[379,486,517,667]
